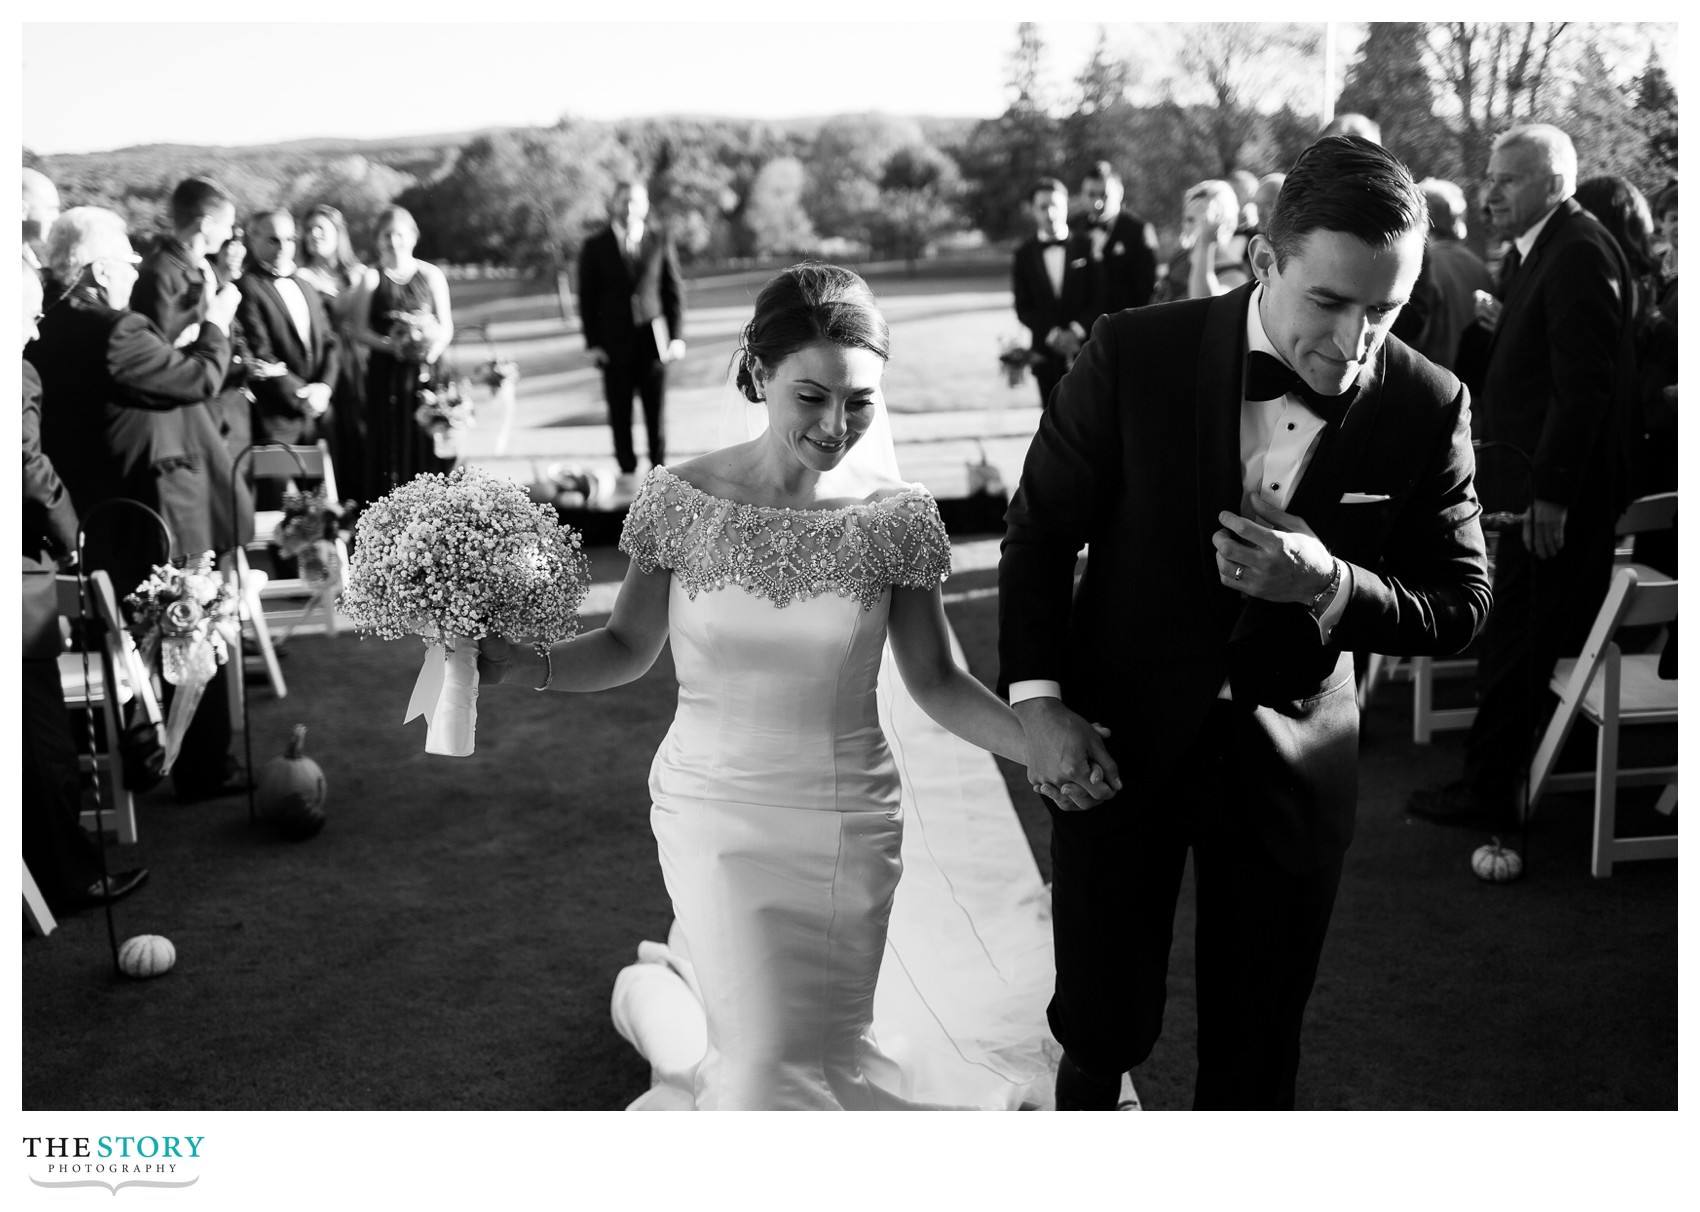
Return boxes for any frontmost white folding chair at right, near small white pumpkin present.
[1527,566,1676,879]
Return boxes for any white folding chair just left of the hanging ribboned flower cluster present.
[58,569,163,843]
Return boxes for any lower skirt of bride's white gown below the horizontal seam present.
[649,799,931,1110]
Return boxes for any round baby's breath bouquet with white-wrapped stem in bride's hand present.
[340,466,590,756]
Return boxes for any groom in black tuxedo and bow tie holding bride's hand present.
[998,138,1489,1110]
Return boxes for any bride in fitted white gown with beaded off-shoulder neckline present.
[479,265,1102,1110]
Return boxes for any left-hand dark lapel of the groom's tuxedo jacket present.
[1193,286,1253,614]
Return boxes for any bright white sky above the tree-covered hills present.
[14,0,1421,155]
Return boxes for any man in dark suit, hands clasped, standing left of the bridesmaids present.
[236,211,338,448]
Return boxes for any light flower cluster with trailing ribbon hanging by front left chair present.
[124,551,241,773]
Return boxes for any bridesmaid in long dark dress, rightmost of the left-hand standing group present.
[350,206,454,498]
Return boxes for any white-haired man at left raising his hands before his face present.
[26,206,245,801]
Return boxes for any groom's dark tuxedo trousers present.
[1049,700,1357,1110]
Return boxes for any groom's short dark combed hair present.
[1265,134,1428,267]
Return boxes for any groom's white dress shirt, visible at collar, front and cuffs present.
[1010,286,1352,704]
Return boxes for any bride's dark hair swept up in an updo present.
[736,262,891,403]
